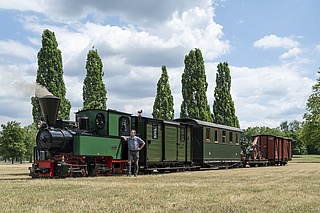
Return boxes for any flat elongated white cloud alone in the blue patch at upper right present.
[253,34,299,49]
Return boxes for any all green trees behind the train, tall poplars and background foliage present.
[0,29,320,161]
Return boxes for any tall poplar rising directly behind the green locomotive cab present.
[82,47,107,109]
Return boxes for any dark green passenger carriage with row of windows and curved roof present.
[175,118,243,167]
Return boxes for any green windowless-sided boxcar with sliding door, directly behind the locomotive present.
[132,116,191,171]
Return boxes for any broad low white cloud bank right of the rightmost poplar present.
[231,64,314,128]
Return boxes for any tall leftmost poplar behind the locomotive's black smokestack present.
[31,29,71,123]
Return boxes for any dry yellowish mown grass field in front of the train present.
[0,156,320,212]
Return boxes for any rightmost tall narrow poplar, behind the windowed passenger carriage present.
[213,62,240,127]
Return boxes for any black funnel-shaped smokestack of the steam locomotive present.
[39,95,61,127]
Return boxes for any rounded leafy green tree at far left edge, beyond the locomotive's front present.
[0,121,27,162]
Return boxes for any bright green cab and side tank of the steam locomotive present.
[73,109,131,160]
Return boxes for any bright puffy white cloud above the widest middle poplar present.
[167,7,230,60]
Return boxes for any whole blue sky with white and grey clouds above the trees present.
[0,0,320,129]
